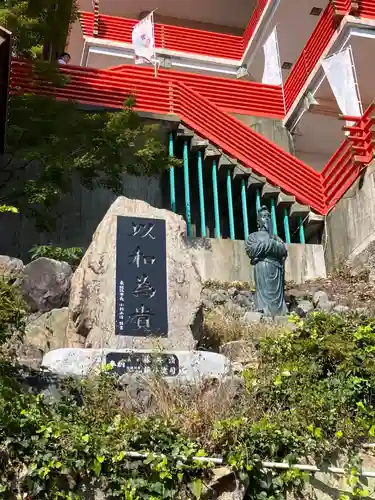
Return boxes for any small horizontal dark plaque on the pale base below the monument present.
[106,352,180,377]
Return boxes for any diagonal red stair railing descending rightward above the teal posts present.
[174,82,324,212]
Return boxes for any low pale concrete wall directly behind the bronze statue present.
[191,238,326,283]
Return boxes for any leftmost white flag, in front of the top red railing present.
[132,12,156,64]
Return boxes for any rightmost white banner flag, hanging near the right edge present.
[322,47,363,125]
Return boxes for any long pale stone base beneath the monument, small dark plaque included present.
[42,348,230,382]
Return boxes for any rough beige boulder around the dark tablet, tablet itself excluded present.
[66,197,203,350]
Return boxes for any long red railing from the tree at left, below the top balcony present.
[8,61,284,118]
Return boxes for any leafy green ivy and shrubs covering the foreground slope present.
[0,313,375,500]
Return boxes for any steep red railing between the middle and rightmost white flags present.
[284,3,336,111]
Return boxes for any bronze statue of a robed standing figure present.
[245,206,288,317]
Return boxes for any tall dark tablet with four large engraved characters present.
[115,216,168,337]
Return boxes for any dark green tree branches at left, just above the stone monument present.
[1,95,180,229]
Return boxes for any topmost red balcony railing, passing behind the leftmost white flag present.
[80,12,244,60]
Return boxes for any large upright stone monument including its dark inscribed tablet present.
[65,197,203,350]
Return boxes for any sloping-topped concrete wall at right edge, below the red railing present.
[323,162,375,270]
